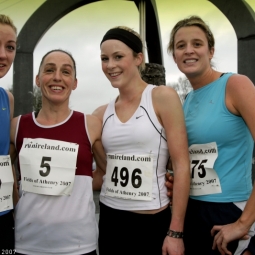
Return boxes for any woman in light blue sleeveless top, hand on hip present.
[168,16,255,255]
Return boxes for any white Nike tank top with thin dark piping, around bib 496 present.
[100,85,169,211]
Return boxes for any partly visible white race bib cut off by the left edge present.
[0,155,14,212]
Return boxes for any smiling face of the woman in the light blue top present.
[173,26,214,78]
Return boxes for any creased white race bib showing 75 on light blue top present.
[189,142,222,196]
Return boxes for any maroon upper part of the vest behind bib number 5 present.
[16,111,93,177]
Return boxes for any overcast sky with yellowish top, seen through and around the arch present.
[0,0,255,113]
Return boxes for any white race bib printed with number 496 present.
[105,153,153,201]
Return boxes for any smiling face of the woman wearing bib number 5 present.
[36,51,77,103]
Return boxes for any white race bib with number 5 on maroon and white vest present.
[19,138,79,196]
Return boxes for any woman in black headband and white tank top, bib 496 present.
[94,27,189,255]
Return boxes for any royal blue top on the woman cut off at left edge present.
[0,87,10,216]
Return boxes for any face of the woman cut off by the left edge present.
[0,24,17,78]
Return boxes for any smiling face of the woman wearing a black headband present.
[101,40,143,88]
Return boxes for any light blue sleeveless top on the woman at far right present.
[183,73,254,202]
